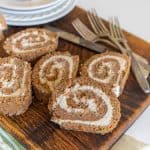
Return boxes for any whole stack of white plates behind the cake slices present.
[0,0,76,26]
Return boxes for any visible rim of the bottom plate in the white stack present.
[7,0,76,26]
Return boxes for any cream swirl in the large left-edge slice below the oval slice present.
[0,58,27,97]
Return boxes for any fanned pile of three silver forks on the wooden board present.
[72,9,150,93]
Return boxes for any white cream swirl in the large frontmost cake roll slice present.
[52,83,113,126]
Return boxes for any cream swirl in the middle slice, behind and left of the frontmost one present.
[39,55,73,87]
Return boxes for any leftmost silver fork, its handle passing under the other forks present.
[72,18,150,74]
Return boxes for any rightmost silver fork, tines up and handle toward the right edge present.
[109,17,150,93]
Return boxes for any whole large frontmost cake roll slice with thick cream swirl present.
[48,78,121,134]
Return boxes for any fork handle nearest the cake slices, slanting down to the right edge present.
[112,39,150,93]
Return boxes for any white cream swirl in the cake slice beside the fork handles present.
[88,55,127,96]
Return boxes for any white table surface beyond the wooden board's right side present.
[77,0,150,144]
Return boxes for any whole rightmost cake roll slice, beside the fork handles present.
[81,52,131,97]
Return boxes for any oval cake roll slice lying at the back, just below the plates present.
[3,28,58,62]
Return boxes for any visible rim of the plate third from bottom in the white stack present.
[0,0,65,15]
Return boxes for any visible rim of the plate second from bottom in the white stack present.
[5,0,71,22]
